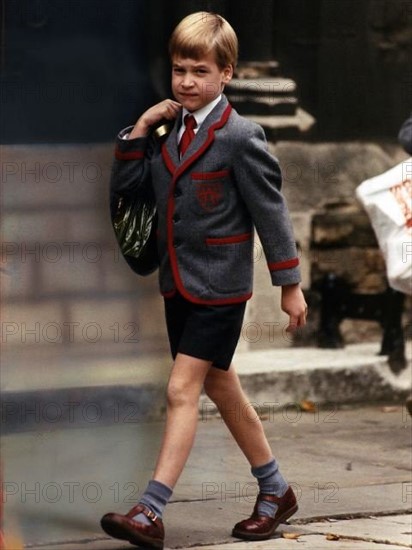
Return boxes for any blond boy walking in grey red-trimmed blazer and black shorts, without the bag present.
[101,12,307,548]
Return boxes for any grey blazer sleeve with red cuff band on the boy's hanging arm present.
[233,123,301,286]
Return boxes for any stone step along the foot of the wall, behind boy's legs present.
[2,342,412,434]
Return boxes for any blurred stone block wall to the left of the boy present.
[1,144,168,392]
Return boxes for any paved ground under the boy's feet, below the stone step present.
[2,404,412,550]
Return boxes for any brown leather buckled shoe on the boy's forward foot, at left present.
[100,504,165,549]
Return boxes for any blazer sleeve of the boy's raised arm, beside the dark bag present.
[110,126,153,216]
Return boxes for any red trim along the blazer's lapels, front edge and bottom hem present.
[162,104,252,305]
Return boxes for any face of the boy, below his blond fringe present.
[172,52,233,112]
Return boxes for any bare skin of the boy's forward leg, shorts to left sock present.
[153,353,212,488]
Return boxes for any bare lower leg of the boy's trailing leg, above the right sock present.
[204,366,273,467]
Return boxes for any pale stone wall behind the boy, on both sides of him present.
[1,142,405,388]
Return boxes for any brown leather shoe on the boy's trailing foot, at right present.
[232,487,298,540]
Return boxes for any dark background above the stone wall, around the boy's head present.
[1,0,412,143]
